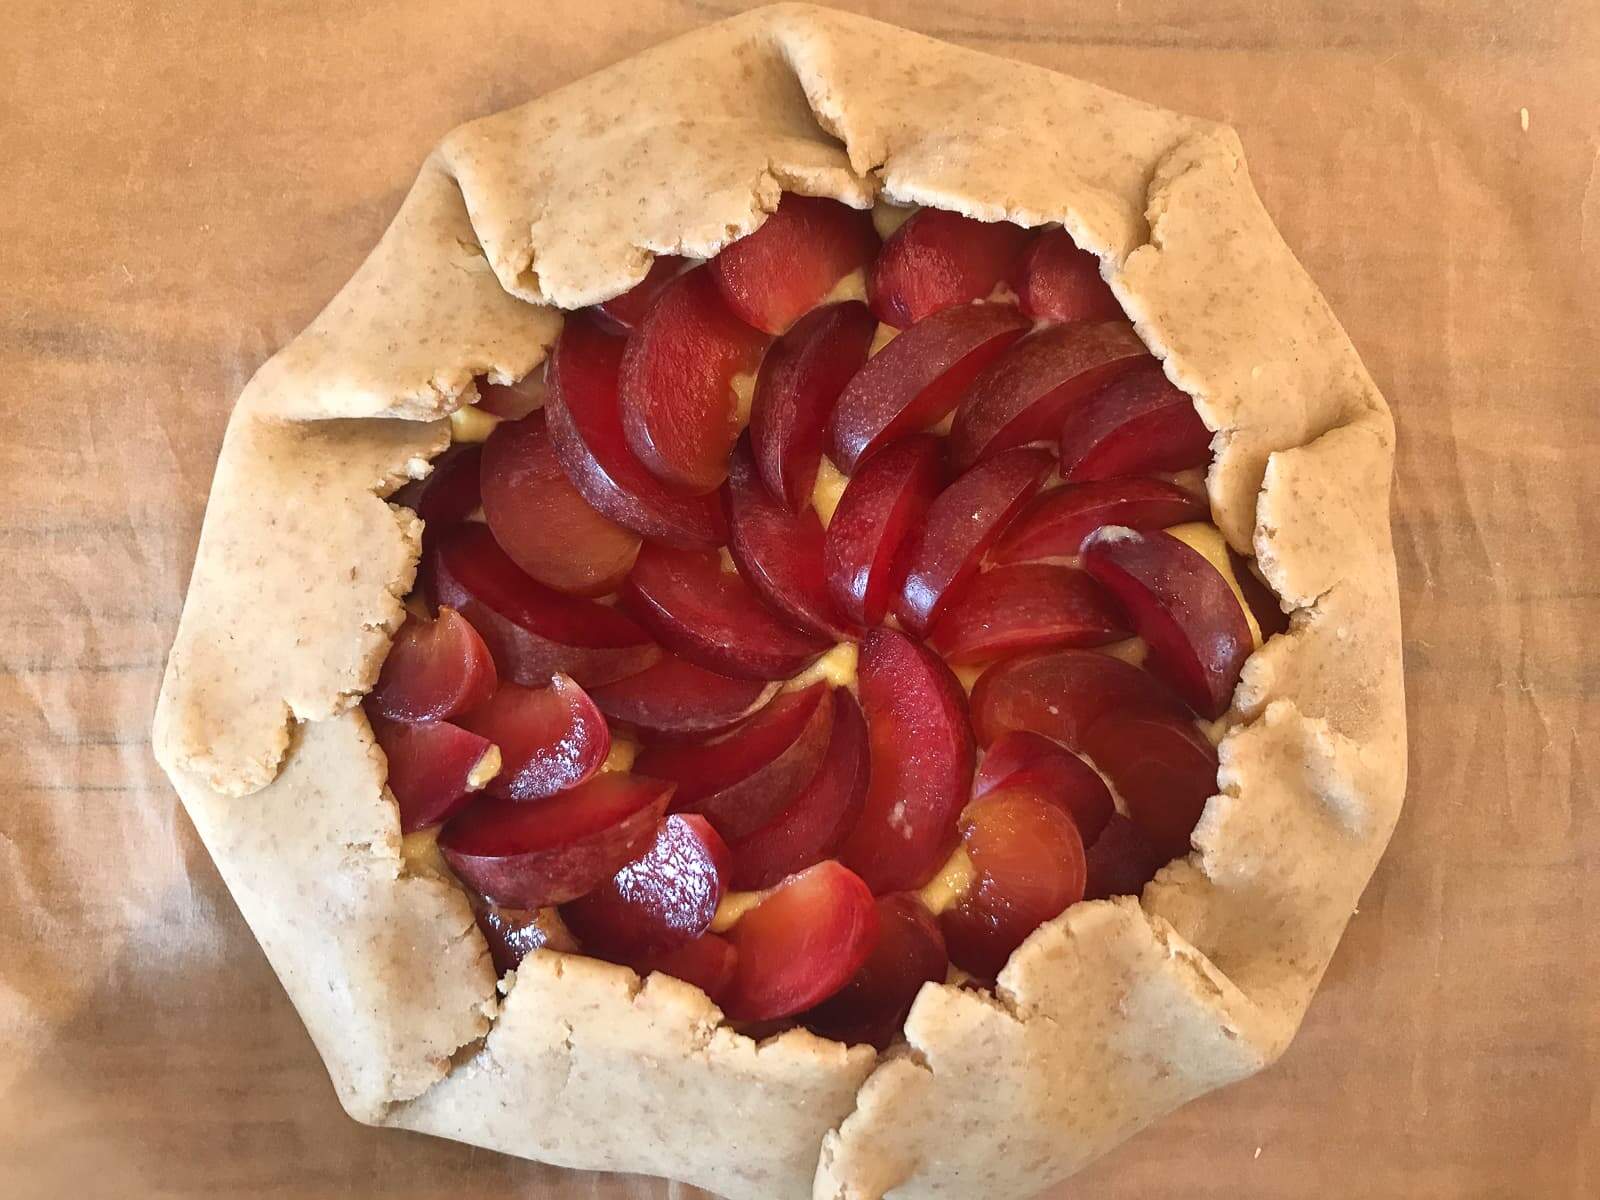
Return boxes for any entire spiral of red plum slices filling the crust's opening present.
[363,195,1288,1050]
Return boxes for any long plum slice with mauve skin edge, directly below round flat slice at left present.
[430,522,661,688]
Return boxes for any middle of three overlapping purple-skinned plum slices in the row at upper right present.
[950,320,1150,470]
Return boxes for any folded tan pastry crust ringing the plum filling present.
[155,5,1405,1200]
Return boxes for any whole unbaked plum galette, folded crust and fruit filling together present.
[157,5,1405,1200]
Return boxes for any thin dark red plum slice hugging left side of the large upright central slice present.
[730,688,870,891]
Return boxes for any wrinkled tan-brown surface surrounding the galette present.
[0,0,1600,1200]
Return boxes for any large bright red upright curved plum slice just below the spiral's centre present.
[838,627,976,894]
